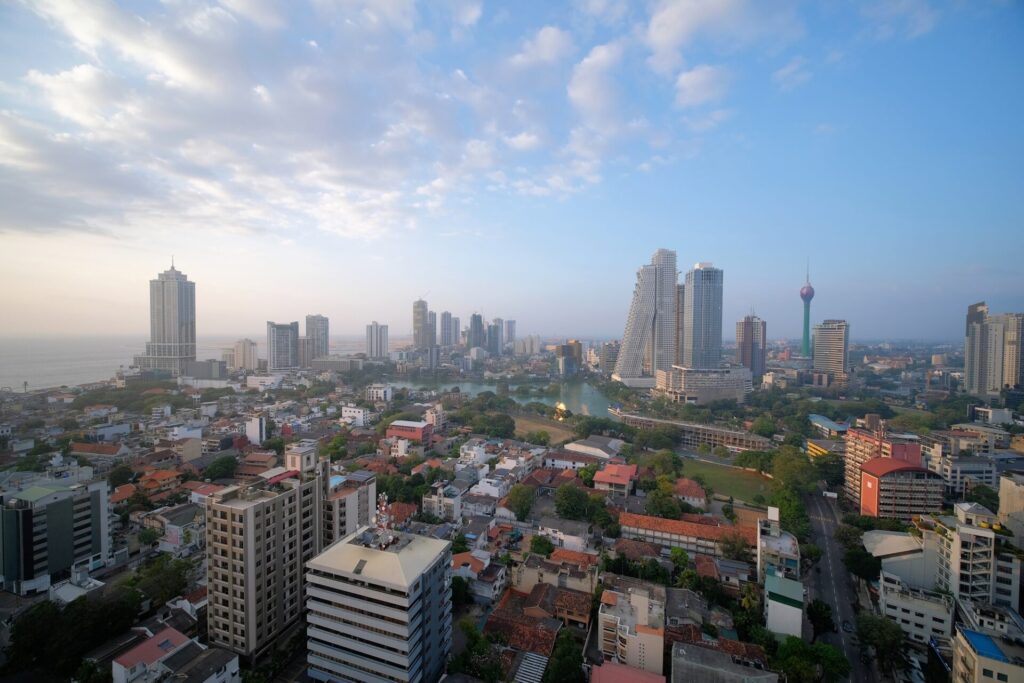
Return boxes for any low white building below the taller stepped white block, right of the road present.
[879,570,955,645]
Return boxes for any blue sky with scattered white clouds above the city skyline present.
[0,0,1024,340]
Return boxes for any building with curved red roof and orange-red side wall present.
[860,458,945,521]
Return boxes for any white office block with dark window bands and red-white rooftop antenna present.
[306,524,452,683]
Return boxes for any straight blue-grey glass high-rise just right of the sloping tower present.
[681,263,723,369]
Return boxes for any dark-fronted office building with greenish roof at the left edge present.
[0,479,111,595]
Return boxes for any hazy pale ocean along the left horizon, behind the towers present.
[0,335,366,391]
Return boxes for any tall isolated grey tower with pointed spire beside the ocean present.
[134,263,196,375]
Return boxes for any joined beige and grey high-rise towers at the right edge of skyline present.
[964,301,1024,396]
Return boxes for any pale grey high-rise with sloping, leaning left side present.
[612,249,678,387]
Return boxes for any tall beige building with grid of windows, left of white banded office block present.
[206,456,327,659]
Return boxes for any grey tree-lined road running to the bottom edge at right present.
[807,495,876,683]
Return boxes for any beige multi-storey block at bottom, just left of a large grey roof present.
[598,582,665,674]
